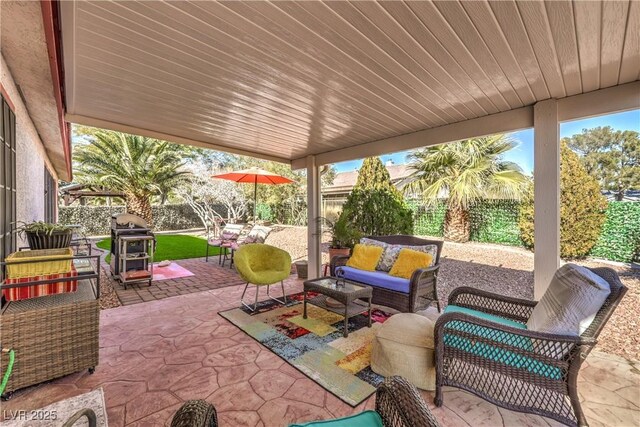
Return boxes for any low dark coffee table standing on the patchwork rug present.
[302,277,373,337]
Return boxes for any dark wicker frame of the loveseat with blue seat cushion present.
[330,235,443,313]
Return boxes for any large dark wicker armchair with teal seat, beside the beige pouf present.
[434,268,627,426]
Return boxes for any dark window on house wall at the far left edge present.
[0,96,16,266]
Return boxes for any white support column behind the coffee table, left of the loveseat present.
[307,156,322,278]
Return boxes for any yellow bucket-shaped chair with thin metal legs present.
[235,243,291,311]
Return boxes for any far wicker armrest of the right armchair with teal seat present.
[448,286,537,323]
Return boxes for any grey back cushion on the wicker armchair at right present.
[527,264,611,336]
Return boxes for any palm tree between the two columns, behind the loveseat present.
[404,135,527,242]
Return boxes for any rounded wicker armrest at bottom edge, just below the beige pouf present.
[376,376,439,427]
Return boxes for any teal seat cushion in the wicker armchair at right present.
[444,305,562,380]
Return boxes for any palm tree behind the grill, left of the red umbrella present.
[74,130,188,225]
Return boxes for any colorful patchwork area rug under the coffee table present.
[219,292,390,406]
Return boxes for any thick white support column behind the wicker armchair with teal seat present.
[533,99,560,300]
